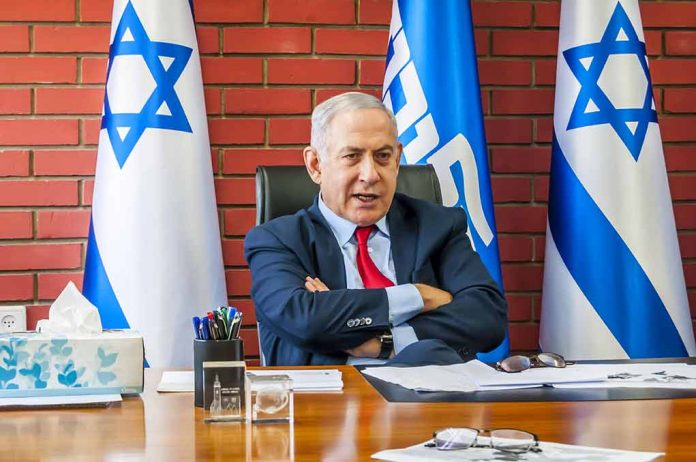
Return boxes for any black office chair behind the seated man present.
[256,165,442,366]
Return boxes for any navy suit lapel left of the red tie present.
[307,196,346,289]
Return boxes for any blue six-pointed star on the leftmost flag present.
[101,2,192,168]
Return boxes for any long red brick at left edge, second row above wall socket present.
[0,244,82,271]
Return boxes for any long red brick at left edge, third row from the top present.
[0,56,77,83]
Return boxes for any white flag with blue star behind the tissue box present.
[83,0,227,368]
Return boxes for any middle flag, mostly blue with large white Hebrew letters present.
[382,0,509,362]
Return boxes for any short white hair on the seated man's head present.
[310,91,398,158]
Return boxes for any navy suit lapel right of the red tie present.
[387,195,418,284]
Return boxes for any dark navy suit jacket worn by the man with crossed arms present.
[244,194,507,366]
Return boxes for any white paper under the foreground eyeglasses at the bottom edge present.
[372,437,664,462]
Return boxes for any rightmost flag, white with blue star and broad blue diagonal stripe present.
[540,0,696,359]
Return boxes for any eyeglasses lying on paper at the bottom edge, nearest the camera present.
[426,427,541,454]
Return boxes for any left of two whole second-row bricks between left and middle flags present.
[223,27,312,53]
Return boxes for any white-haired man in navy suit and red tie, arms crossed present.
[244,93,507,365]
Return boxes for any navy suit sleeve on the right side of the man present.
[408,210,507,356]
